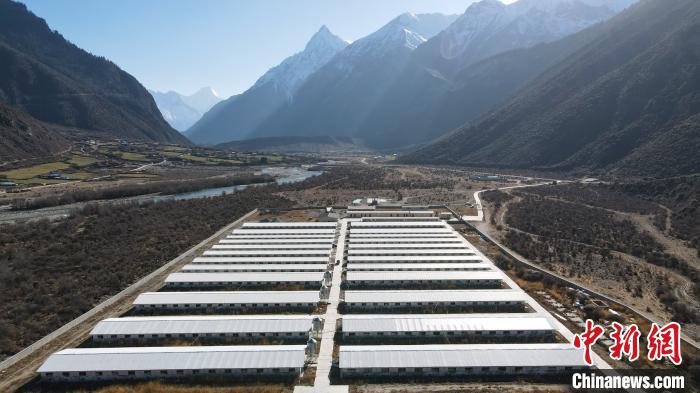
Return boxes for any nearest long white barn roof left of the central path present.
[38,345,305,373]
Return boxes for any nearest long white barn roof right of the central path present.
[340,344,586,369]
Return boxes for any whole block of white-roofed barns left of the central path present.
[38,222,336,381]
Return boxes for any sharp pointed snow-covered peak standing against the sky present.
[251,25,348,99]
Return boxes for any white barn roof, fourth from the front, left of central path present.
[165,272,323,284]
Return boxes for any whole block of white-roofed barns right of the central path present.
[338,210,585,379]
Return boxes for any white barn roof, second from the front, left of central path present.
[90,315,314,336]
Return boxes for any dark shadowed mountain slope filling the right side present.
[404,0,700,176]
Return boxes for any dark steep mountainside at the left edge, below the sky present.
[0,0,189,144]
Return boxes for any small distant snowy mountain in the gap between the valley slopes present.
[149,87,221,131]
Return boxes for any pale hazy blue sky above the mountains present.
[21,0,486,97]
